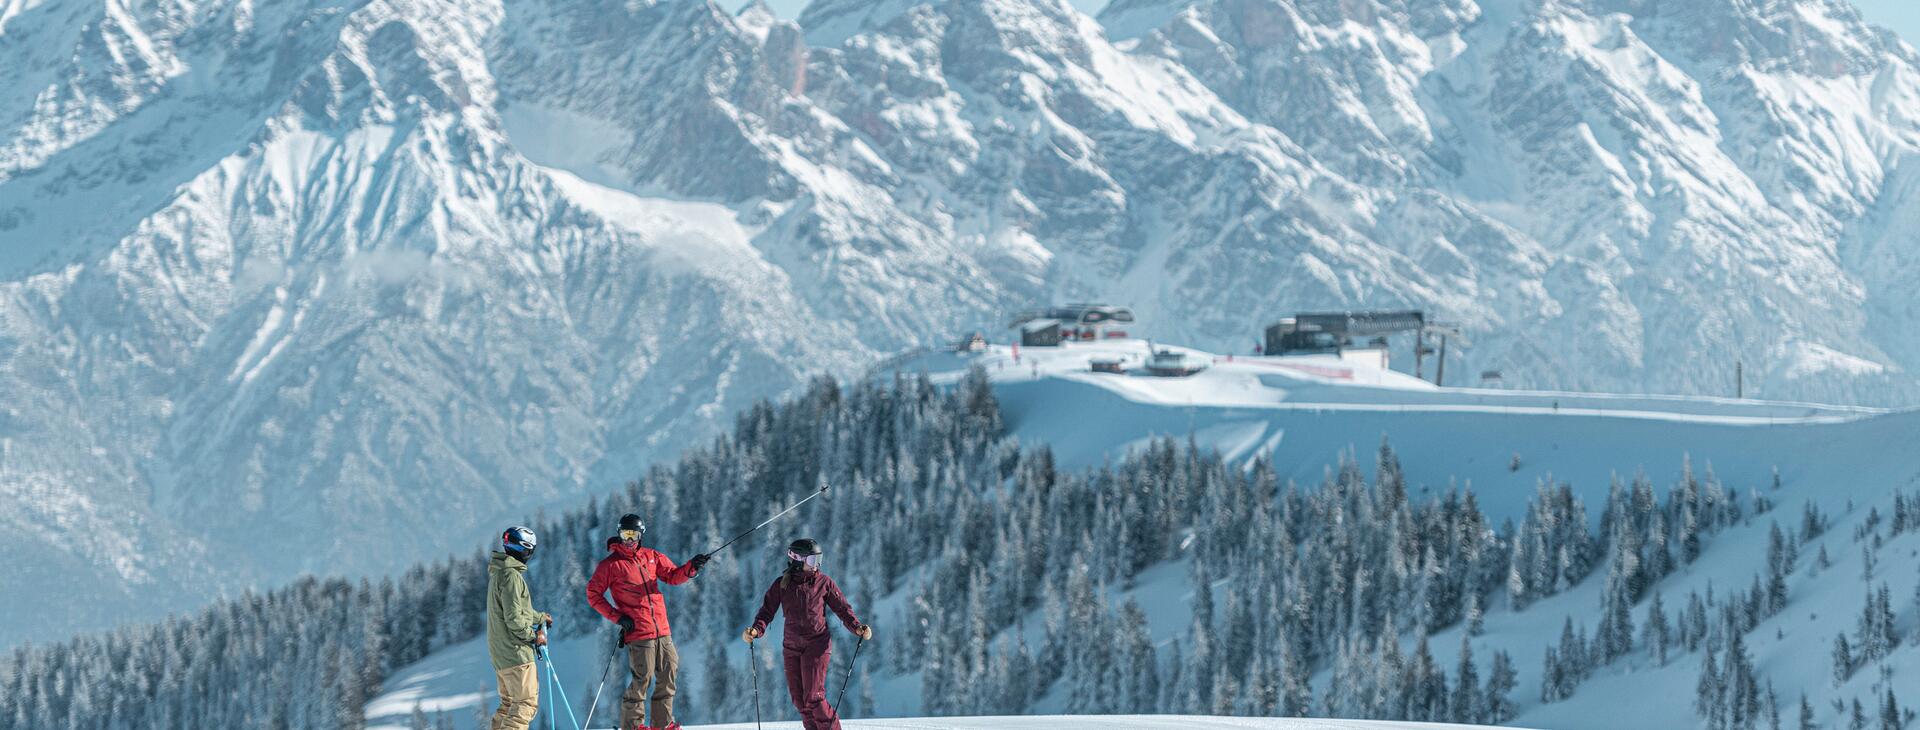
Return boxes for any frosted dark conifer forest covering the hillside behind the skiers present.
[0,371,1920,730]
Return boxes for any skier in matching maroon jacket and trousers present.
[741,538,874,730]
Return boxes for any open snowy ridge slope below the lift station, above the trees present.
[874,340,1920,521]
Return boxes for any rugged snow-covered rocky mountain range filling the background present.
[11,0,1920,644]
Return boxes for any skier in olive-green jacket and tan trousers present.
[486,526,553,730]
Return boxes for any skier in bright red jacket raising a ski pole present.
[588,515,708,730]
